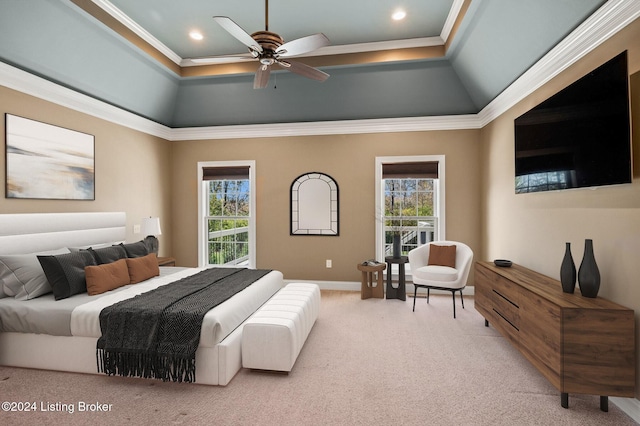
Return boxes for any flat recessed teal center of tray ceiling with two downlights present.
[110,0,454,58]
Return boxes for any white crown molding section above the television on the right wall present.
[478,0,640,127]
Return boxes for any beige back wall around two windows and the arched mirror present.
[172,130,480,282]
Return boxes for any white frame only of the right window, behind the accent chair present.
[375,155,446,262]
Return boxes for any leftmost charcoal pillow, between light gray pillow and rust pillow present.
[38,250,96,300]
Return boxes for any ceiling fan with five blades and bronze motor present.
[193,0,329,89]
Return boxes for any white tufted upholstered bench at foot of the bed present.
[242,283,320,372]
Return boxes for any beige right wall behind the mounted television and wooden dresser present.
[481,15,640,397]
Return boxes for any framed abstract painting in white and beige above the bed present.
[5,114,95,200]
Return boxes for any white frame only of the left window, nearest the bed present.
[198,160,256,268]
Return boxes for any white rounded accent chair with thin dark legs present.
[409,241,473,318]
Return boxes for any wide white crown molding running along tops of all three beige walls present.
[0,0,640,141]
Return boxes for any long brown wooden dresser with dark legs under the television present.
[475,262,636,411]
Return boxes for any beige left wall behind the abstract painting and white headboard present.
[0,86,172,255]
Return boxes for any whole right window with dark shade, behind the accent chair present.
[376,155,445,260]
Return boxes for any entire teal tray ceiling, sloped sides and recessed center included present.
[0,0,605,128]
